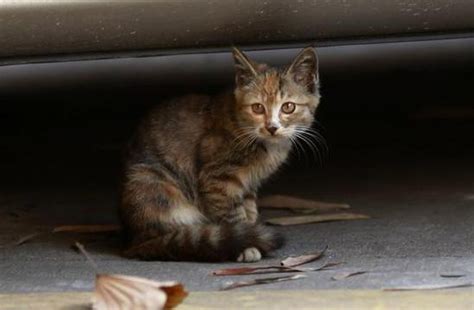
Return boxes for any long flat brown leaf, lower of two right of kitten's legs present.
[266,213,370,226]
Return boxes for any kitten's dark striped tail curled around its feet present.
[125,223,283,262]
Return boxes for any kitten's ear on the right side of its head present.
[285,47,319,93]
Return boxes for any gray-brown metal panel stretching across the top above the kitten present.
[0,0,474,63]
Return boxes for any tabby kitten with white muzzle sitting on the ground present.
[120,48,320,262]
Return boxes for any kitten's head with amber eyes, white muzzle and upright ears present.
[233,47,320,142]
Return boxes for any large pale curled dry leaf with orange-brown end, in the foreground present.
[92,274,188,310]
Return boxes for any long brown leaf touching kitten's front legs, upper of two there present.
[257,195,350,211]
